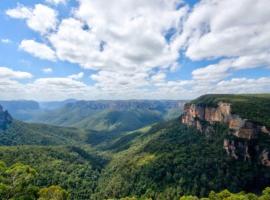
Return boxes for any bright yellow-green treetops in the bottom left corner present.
[0,161,69,200]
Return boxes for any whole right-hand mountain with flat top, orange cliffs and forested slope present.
[96,95,270,199]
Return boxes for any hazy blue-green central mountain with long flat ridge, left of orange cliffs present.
[31,100,184,131]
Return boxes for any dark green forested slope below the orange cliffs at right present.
[95,119,270,200]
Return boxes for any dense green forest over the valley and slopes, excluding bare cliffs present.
[0,95,270,200]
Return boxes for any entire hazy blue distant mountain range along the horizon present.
[0,99,185,131]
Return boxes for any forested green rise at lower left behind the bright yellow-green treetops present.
[0,146,104,199]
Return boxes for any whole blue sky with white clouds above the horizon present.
[0,0,270,101]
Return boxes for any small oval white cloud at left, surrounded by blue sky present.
[19,40,56,61]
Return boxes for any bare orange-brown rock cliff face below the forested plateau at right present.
[181,102,270,167]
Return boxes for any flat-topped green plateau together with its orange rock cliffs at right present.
[181,94,270,167]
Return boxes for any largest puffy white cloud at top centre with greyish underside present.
[49,0,186,71]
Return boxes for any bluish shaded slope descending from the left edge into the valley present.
[0,106,88,145]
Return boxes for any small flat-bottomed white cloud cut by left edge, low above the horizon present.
[0,67,32,79]
